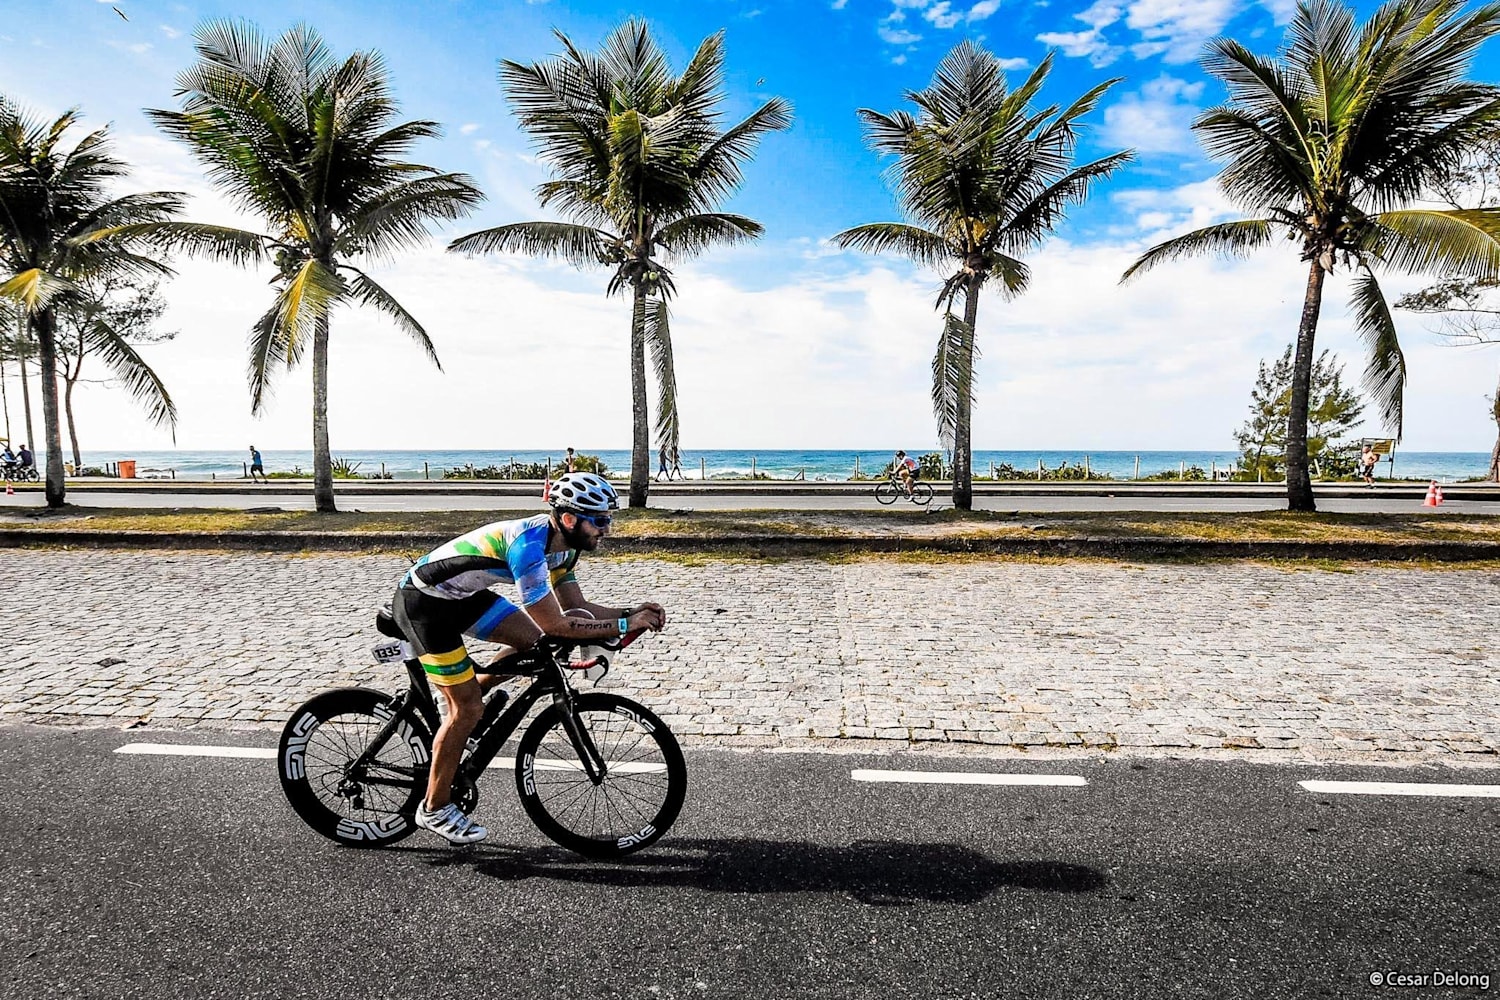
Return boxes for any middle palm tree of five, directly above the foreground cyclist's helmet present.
[450,19,792,507]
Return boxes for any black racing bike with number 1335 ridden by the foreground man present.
[276,610,687,859]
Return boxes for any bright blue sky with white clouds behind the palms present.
[0,0,1500,450]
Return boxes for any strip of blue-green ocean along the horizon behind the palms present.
[46,448,1490,483]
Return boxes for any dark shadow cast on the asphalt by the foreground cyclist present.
[431,838,1109,906]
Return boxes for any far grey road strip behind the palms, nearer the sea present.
[0,487,1500,514]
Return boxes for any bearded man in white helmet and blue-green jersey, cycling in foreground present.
[392,472,666,844]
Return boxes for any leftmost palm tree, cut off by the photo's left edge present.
[0,100,182,507]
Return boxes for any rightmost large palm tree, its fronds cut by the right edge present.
[1122,0,1500,511]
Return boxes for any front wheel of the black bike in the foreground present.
[516,693,687,858]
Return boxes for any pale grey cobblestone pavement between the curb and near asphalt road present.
[0,550,1500,763]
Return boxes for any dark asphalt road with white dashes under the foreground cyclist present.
[0,724,1500,1000]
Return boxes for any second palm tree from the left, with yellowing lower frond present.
[149,21,483,511]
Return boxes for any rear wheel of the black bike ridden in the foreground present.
[276,688,432,847]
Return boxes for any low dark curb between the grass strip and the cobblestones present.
[0,528,1500,562]
